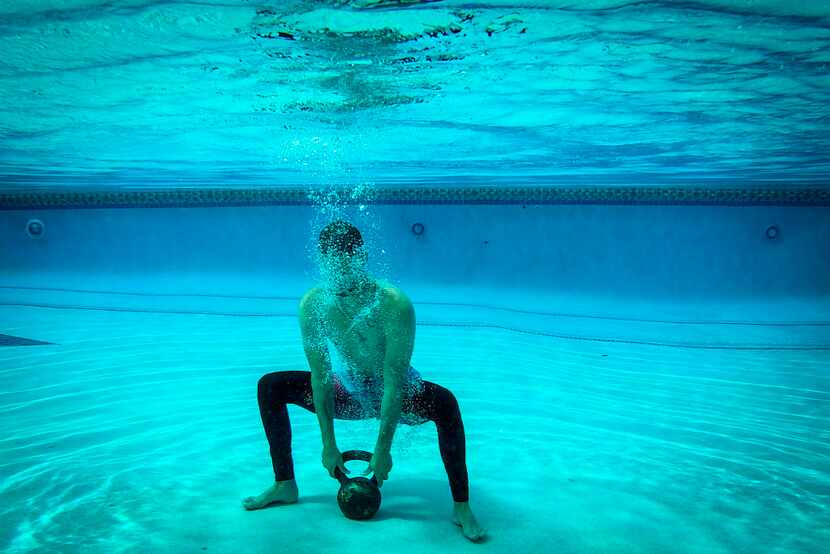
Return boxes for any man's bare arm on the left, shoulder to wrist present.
[299,289,337,450]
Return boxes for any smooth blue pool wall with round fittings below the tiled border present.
[0,190,830,299]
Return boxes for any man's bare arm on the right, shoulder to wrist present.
[375,291,415,453]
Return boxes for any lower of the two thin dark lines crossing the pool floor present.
[0,302,830,351]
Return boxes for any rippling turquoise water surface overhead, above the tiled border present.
[0,0,830,188]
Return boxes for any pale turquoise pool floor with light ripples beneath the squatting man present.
[0,292,830,553]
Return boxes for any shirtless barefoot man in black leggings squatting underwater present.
[242,220,486,541]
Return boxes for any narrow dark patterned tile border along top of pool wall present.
[0,185,830,210]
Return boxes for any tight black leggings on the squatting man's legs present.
[257,371,469,502]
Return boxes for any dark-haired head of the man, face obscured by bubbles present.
[318,220,368,290]
